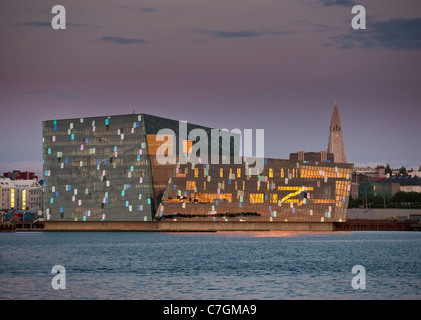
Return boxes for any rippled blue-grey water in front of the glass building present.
[0,231,421,300]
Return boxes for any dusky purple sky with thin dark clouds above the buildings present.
[0,0,421,175]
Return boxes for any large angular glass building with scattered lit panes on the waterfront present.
[43,114,353,222]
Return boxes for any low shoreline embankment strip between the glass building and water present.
[5,219,421,232]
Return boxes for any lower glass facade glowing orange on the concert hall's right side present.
[156,159,353,222]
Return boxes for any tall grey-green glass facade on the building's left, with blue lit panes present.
[43,114,155,221]
